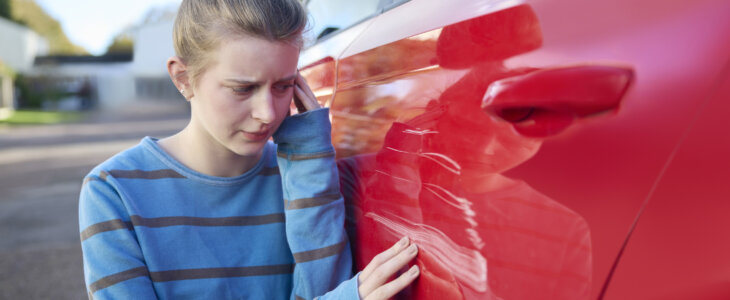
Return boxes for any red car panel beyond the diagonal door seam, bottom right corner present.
[606,63,730,299]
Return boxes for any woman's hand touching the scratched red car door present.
[358,237,420,300]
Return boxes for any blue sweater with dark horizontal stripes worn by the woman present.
[79,109,359,299]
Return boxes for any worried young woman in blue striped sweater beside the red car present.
[79,0,419,299]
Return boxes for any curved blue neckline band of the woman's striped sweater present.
[141,136,271,185]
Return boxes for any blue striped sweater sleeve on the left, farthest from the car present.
[79,171,157,299]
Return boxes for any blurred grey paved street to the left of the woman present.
[0,101,188,299]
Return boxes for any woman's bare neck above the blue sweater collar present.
[158,121,262,177]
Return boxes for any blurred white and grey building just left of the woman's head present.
[27,6,183,109]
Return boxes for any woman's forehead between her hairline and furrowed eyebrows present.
[211,35,299,80]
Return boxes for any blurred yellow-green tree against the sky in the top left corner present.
[9,0,88,55]
